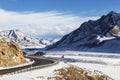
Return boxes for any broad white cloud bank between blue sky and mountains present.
[0,9,98,39]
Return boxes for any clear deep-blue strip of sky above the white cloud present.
[0,0,120,16]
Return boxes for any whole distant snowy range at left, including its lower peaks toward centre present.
[0,29,59,48]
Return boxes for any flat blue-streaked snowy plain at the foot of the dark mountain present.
[45,51,120,66]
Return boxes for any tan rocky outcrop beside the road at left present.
[0,40,26,67]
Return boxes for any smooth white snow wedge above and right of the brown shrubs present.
[71,63,120,80]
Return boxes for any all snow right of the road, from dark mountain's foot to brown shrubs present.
[46,51,120,80]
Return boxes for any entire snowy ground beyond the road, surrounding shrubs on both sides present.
[0,51,120,80]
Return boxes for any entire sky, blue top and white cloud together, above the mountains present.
[0,0,120,38]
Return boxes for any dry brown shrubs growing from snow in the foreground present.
[54,65,112,80]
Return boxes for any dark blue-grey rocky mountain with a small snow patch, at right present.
[47,11,120,52]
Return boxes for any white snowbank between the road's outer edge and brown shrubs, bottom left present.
[0,62,67,80]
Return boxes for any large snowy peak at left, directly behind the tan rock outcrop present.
[0,30,46,48]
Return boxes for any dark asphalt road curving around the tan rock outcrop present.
[0,57,54,75]
